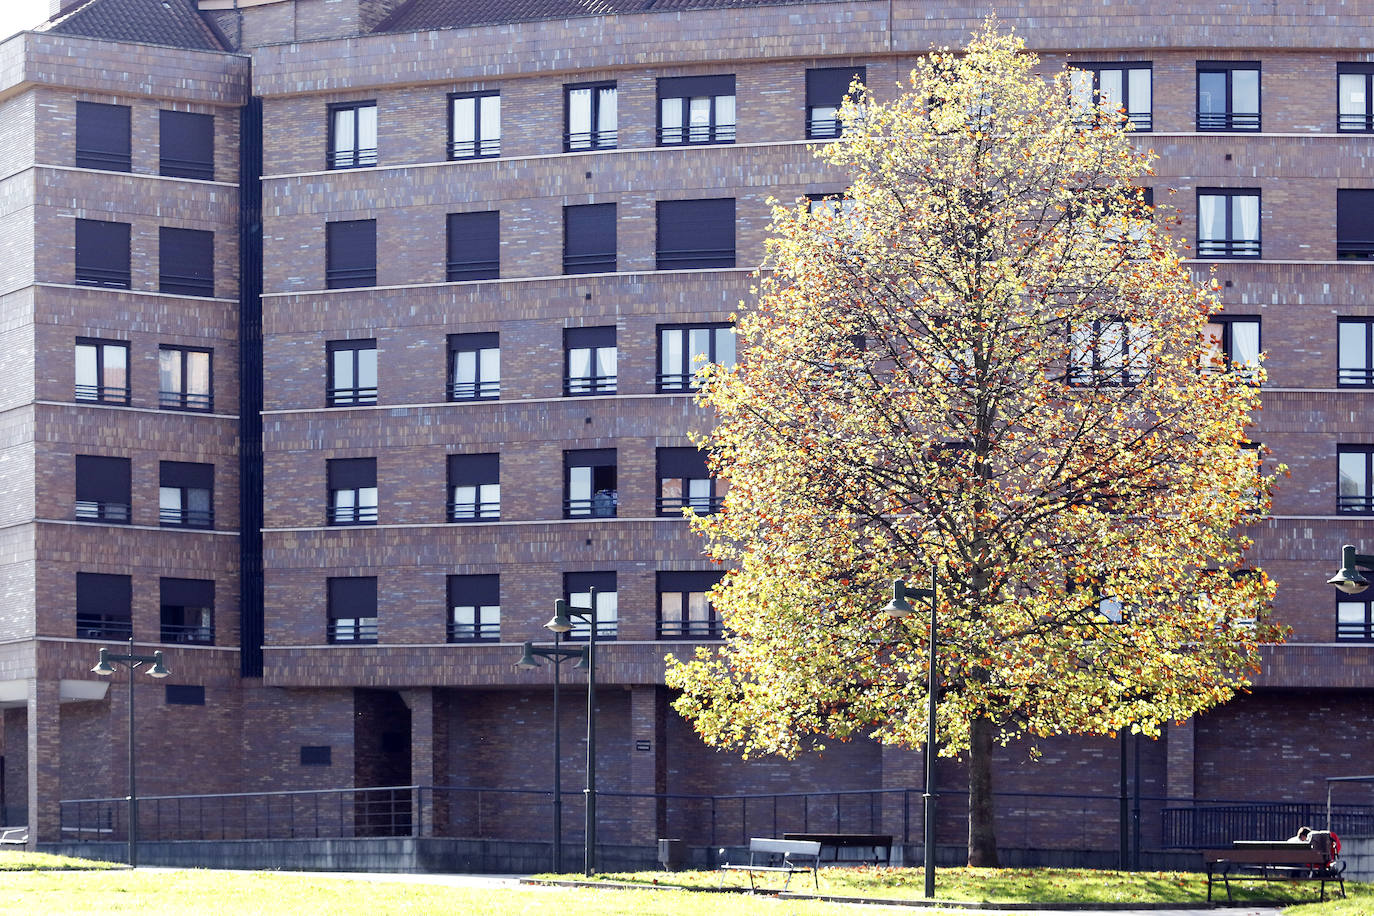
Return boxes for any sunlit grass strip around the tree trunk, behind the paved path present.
[574,867,1374,916]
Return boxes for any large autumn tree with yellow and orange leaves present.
[668,25,1275,865]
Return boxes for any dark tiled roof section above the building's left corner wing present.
[45,0,228,51]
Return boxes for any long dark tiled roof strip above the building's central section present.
[374,0,807,32]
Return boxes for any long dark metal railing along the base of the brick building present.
[62,786,1374,853]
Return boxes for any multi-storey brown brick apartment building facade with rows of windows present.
[0,0,1374,862]
